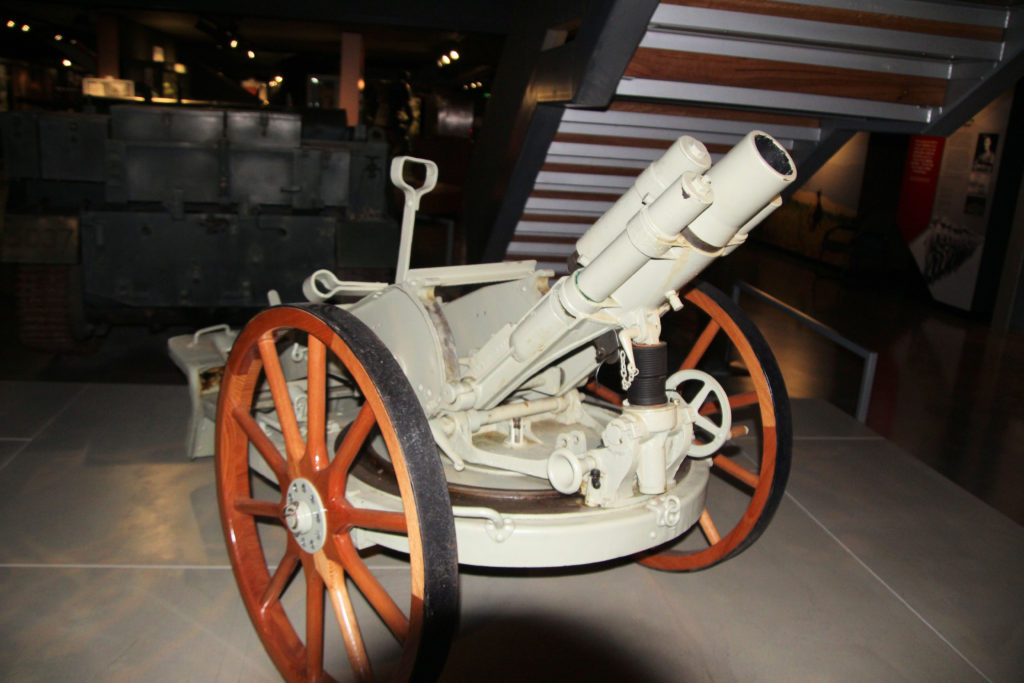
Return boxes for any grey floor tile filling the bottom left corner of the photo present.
[0,566,280,683]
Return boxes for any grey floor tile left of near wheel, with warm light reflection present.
[0,385,226,565]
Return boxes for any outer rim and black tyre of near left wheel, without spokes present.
[216,304,459,680]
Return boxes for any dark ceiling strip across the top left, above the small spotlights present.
[0,0,514,80]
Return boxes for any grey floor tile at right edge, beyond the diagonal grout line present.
[787,440,1024,680]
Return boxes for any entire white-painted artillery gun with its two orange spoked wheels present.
[171,131,796,680]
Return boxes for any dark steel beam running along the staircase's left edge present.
[464,0,657,262]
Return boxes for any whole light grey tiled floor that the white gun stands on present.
[0,382,1024,681]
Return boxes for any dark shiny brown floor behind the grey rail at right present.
[705,244,1024,524]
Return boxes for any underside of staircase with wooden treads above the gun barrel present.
[489,0,1024,273]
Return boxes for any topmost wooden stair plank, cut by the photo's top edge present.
[662,0,1004,43]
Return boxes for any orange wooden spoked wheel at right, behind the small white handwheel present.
[585,283,793,571]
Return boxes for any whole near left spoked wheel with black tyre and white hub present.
[216,304,459,681]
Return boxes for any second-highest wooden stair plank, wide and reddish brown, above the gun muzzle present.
[626,47,946,105]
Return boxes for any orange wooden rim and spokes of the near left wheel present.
[216,308,424,681]
